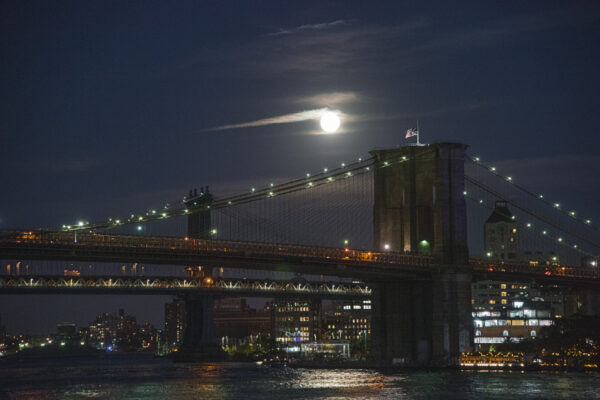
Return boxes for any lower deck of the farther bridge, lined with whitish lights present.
[0,275,371,299]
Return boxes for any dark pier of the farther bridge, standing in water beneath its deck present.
[176,295,224,361]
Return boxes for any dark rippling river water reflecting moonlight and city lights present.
[0,356,600,400]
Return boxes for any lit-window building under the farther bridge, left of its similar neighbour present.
[272,299,324,346]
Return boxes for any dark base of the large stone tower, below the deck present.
[371,272,473,366]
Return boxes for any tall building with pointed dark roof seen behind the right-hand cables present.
[483,201,519,261]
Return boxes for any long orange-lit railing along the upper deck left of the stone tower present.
[0,231,436,266]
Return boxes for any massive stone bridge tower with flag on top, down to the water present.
[371,143,473,366]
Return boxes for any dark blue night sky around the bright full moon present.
[0,1,600,331]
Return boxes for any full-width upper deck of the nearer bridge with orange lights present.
[0,230,600,286]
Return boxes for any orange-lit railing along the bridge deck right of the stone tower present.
[469,259,600,279]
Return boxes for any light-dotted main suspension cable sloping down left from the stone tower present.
[61,150,418,231]
